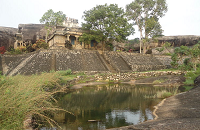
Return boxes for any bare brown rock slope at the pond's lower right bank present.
[110,86,200,130]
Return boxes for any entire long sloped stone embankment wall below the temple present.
[0,49,170,76]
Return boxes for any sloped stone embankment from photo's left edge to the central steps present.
[0,50,108,76]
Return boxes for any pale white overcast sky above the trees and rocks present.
[0,0,200,39]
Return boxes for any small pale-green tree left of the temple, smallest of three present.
[40,9,66,42]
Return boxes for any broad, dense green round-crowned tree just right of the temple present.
[80,4,134,50]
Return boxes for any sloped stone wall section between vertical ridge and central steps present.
[56,50,107,71]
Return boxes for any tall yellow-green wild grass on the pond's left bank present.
[0,73,70,130]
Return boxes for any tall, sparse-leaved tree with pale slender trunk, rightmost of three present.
[126,0,167,53]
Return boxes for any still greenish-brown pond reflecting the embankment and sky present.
[41,84,189,130]
